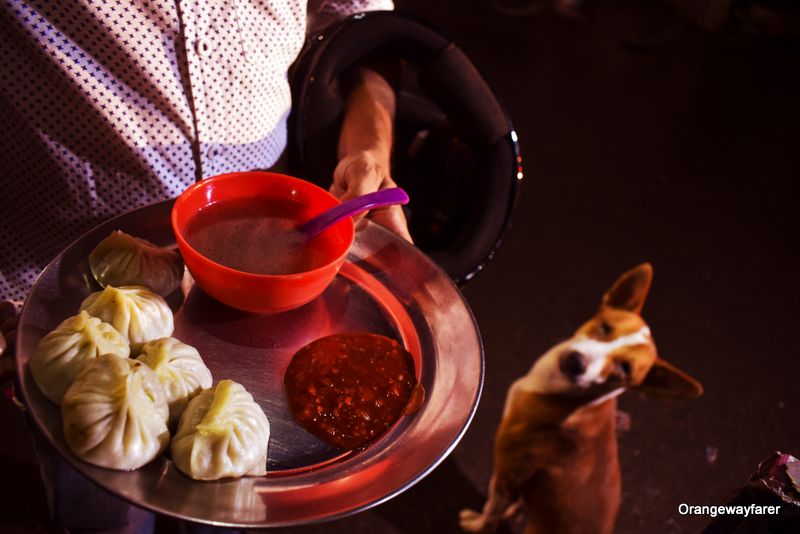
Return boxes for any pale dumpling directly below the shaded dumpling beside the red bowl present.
[81,286,174,355]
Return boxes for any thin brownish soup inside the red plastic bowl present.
[184,197,330,274]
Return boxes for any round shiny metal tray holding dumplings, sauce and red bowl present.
[17,201,483,528]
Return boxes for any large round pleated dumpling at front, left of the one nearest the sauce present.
[61,354,169,471]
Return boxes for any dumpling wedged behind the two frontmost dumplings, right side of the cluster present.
[136,337,212,428]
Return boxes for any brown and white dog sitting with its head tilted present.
[460,263,703,534]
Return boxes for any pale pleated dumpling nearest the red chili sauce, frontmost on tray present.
[171,380,269,480]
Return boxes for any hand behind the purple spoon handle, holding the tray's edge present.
[330,151,414,243]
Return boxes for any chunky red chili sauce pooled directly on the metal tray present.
[284,333,423,449]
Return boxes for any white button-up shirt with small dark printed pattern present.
[0,0,393,301]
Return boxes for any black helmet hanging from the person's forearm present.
[289,12,522,284]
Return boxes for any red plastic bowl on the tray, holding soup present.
[172,171,355,313]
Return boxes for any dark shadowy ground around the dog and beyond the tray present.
[0,0,800,534]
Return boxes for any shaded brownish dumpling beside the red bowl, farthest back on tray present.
[89,230,183,297]
